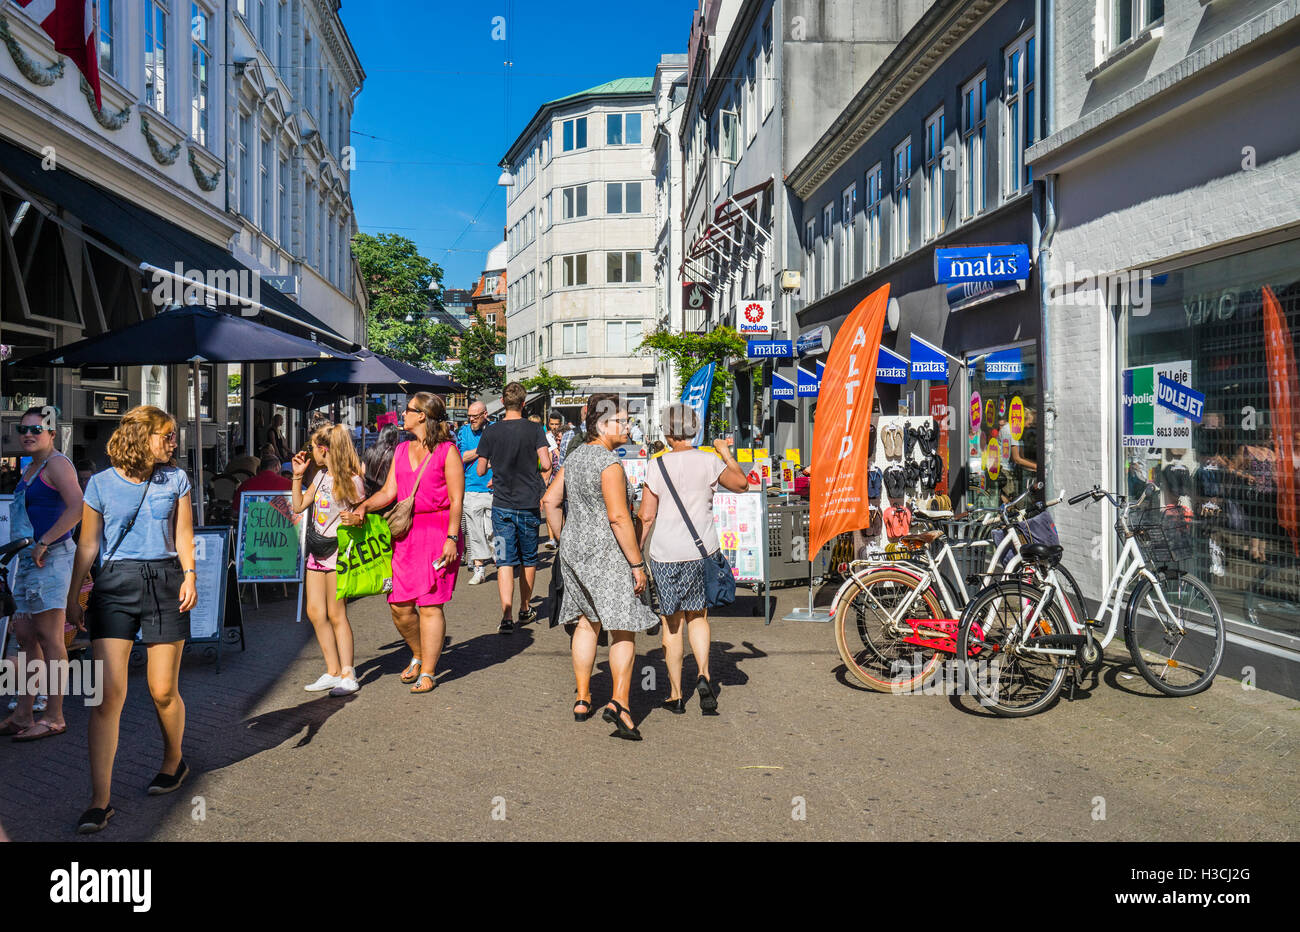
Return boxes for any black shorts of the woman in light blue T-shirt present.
[86,558,190,643]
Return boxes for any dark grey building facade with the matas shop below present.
[788,0,1041,507]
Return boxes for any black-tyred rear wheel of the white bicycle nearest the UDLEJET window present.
[957,580,1070,718]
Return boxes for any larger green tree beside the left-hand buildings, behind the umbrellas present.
[352,233,455,368]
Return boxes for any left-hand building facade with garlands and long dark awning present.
[0,0,360,491]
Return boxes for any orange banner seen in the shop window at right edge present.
[1264,285,1300,555]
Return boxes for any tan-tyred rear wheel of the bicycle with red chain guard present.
[835,568,944,693]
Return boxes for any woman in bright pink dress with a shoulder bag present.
[348,391,465,693]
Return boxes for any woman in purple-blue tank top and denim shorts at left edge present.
[0,408,82,741]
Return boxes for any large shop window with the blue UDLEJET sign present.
[1118,242,1300,636]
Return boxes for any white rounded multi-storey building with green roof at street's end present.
[502,78,657,424]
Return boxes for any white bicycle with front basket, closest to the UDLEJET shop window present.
[957,485,1225,716]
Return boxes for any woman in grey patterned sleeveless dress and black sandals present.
[543,393,659,741]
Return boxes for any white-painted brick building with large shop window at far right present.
[1028,0,1300,681]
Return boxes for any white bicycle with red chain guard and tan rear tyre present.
[831,482,1084,693]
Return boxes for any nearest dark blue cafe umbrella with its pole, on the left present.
[9,305,347,525]
